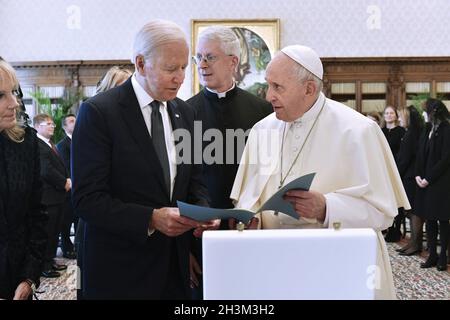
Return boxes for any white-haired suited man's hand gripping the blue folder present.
[149,208,200,237]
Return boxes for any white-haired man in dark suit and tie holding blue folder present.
[72,20,213,299]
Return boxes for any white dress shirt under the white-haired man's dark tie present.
[131,74,177,198]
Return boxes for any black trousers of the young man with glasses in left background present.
[44,203,64,270]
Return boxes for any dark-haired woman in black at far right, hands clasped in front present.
[415,98,450,271]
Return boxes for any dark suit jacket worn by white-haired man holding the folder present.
[72,79,207,299]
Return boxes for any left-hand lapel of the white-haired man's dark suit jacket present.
[119,78,170,198]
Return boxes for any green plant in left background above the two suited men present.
[31,90,82,143]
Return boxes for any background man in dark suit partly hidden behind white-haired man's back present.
[56,114,78,259]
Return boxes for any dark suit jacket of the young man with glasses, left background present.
[38,139,69,206]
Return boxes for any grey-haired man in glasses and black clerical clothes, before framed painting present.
[187,26,272,298]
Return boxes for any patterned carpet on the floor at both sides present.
[37,243,450,300]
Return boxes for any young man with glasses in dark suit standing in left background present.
[33,114,71,278]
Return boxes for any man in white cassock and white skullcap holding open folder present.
[231,45,410,299]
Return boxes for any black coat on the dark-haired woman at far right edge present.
[415,122,450,220]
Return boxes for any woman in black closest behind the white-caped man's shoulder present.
[381,106,405,242]
